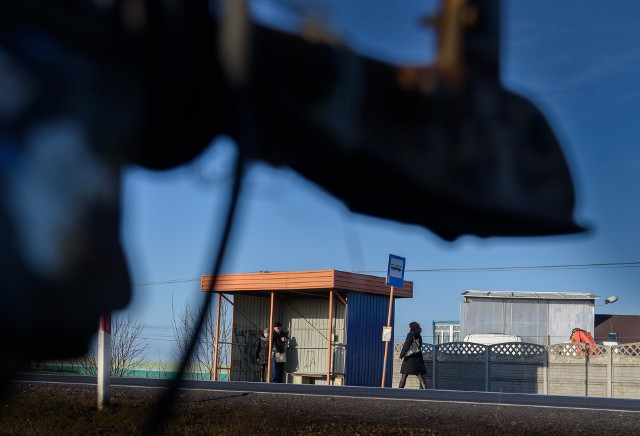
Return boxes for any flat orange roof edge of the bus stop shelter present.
[200,269,413,298]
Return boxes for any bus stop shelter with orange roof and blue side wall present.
[201,270,413,386]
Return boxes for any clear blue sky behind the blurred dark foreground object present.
[117,0,640,358]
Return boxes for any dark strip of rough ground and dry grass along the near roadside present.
[0,383,640,435]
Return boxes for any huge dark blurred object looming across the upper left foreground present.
[0,0,580,388]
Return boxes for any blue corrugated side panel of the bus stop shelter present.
[344,292,395,387]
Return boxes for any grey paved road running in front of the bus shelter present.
[15,373,640,412]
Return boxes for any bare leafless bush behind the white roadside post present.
[74,314,149,377]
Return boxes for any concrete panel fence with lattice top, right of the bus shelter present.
[393,342,640,399]
